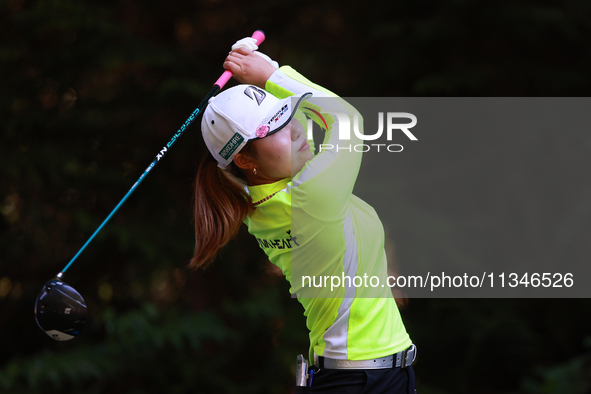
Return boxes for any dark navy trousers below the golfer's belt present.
[294,366,415,394]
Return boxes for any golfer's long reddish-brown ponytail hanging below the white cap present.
[189,143,256,269]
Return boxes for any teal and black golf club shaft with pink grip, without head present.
[57,30,265,278]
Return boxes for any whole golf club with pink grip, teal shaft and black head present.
[35,30,265,341]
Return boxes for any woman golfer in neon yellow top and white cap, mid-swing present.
[190,39,416,393]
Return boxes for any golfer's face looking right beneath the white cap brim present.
[254,119,314,180]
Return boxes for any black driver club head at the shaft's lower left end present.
[35,278,87,341]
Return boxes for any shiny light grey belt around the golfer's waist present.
[314,344,417,369]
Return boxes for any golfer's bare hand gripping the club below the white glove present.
[224,48,276,89]
